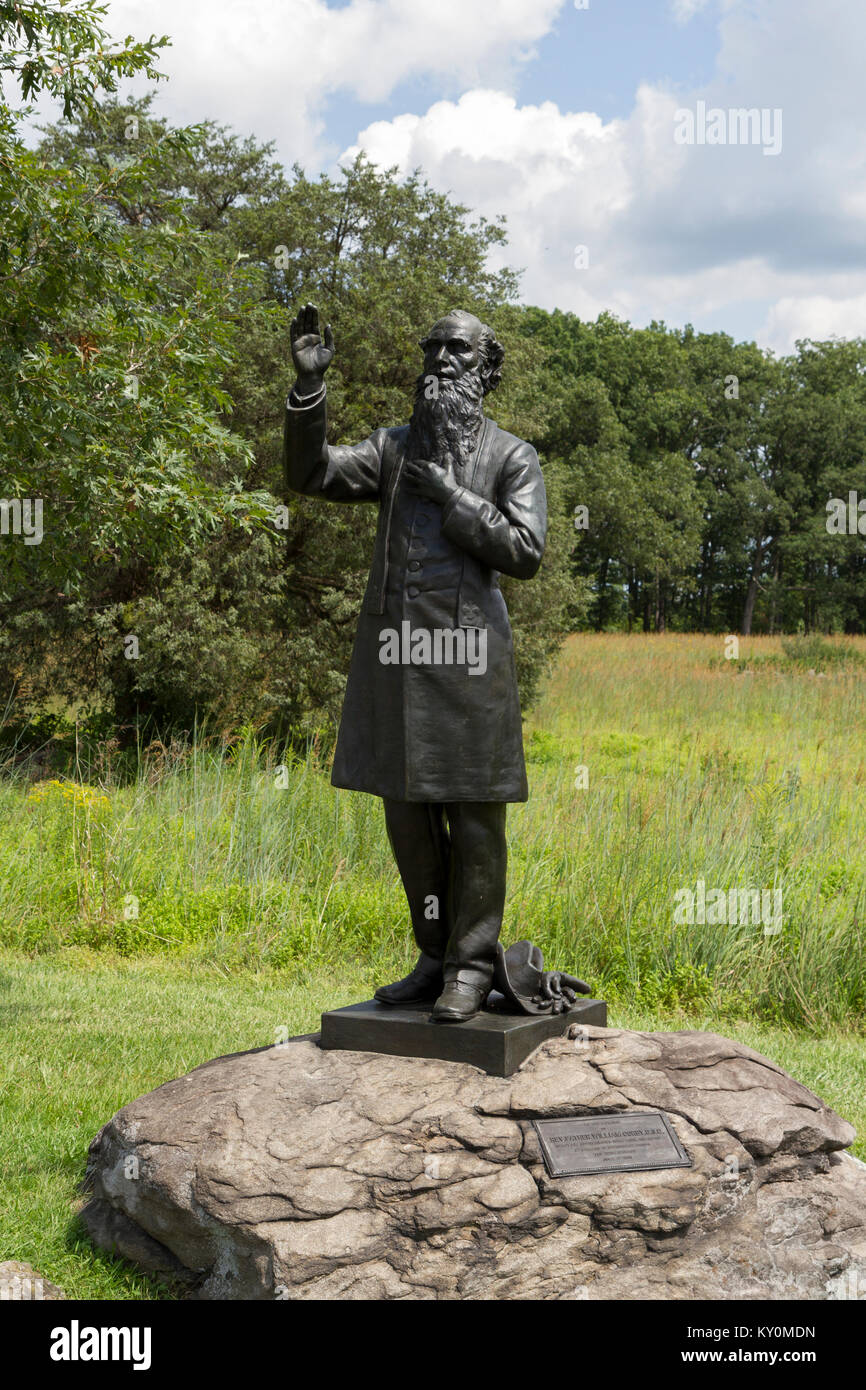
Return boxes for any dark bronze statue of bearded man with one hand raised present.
[285,304,546,1023]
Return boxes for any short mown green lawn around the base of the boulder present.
[0,948,866,1300]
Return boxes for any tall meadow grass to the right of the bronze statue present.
[522,635,866,1031]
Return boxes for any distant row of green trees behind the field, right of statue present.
[523,309,866,634]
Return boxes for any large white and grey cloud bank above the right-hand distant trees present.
[349,0,866,350]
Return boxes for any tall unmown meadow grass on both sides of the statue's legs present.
[0,635,866,1031]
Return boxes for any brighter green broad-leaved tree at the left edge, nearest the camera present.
[0,81,275,723]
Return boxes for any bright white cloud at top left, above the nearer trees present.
[101,0,564,165]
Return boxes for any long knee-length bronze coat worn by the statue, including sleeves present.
[284,389,546,802]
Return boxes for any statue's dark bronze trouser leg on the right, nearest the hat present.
[445,801,507,990]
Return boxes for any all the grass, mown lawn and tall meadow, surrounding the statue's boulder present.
[0,635,866,1298]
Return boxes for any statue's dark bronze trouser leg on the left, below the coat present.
[382,798,450,960]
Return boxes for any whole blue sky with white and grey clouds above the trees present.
[67,0,866,352]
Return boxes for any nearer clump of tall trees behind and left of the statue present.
[0,88,572,738]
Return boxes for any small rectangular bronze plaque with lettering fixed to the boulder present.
[532,1111,692,1177]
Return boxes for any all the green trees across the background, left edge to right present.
[0,0,866,750]
